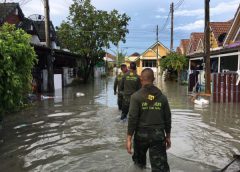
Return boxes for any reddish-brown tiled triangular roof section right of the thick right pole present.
[210,21,232,46]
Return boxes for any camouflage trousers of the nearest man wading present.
[132,129,170,172]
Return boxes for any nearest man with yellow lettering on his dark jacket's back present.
[127,68,171,172]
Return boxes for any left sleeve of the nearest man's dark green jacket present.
[128,95,140,136]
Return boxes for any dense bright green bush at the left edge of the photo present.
[0,24,36,115]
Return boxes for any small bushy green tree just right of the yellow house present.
[160,52,188,84]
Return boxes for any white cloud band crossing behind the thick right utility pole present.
[175,0,239,18]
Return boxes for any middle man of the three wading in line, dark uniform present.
[120,62,141,120]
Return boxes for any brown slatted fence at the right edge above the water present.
[213,73,240,103]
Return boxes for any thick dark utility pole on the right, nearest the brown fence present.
[204,0,211,94]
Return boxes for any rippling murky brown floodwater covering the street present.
[0,78,240,172]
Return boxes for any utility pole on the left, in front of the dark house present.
[44,0,54,93]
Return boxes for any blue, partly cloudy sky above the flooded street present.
[2,0,240,55]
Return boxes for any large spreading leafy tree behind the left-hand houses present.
[57,0,130,81]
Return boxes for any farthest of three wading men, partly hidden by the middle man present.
[113,64,128,110]
